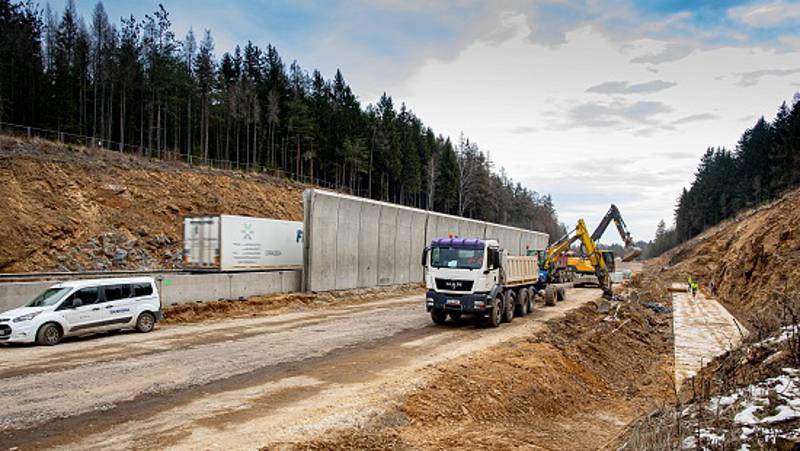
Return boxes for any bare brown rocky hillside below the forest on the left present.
[0,136,304,272]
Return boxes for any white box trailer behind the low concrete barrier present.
[183,215,303,271]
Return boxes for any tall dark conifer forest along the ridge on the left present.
[0,0,563,237]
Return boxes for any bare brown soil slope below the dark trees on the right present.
[649,190,800,330]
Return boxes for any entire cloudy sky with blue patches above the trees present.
[57,0,800,241]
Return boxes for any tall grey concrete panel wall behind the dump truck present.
[303,189,548,291]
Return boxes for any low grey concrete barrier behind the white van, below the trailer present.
[0,270,302,312]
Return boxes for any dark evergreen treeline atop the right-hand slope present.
[649,93,800,256]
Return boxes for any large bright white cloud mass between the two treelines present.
[390,16,800,240]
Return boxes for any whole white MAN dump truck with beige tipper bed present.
[422,238,539,327]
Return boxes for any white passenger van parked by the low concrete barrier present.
[0,277,163,346]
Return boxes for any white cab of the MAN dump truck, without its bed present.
[422,238,502,323]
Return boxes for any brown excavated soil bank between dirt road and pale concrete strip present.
[287,294,673,449]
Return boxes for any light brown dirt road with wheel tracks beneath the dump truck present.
[0,289,598,449]
